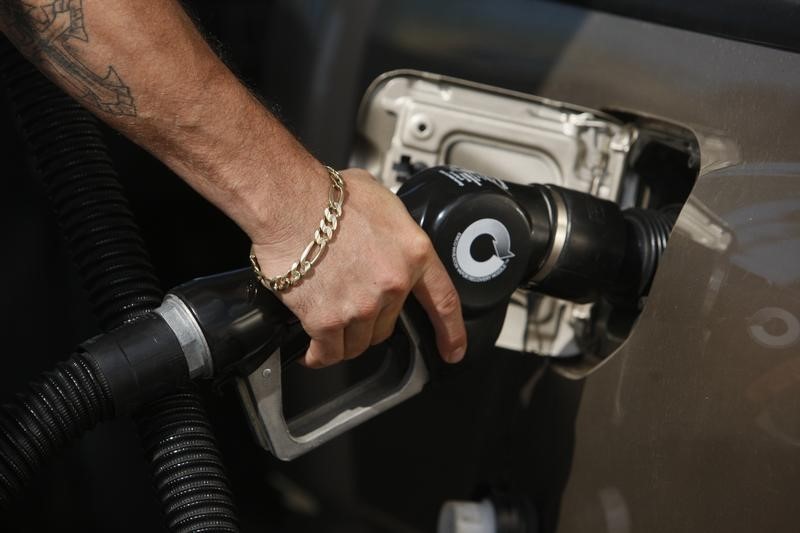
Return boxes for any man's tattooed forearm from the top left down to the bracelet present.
[0,0,326,241]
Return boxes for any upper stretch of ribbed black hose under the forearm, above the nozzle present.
[0,39,162,331]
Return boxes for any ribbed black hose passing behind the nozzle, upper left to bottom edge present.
[0,40,238,531]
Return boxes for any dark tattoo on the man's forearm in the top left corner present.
[0,0,136,117]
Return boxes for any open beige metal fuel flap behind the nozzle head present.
[352,71,699,370]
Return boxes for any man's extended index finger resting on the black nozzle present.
[412,254,467,363]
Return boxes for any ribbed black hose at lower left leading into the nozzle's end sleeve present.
[0,353,114,509]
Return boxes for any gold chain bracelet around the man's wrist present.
[250,167,344,292]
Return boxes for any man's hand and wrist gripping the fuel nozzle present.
[254,169,466,367]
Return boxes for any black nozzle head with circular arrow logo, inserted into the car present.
[398,167,675,324]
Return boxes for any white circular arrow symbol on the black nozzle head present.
[453,218,514,281]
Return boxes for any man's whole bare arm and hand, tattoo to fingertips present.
[0,0,466,367]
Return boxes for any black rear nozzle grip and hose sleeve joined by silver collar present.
[81,269,294,414]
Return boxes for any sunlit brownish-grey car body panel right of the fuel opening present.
[524,9,800,533]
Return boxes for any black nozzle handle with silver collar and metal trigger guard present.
[158,269,429,460]
